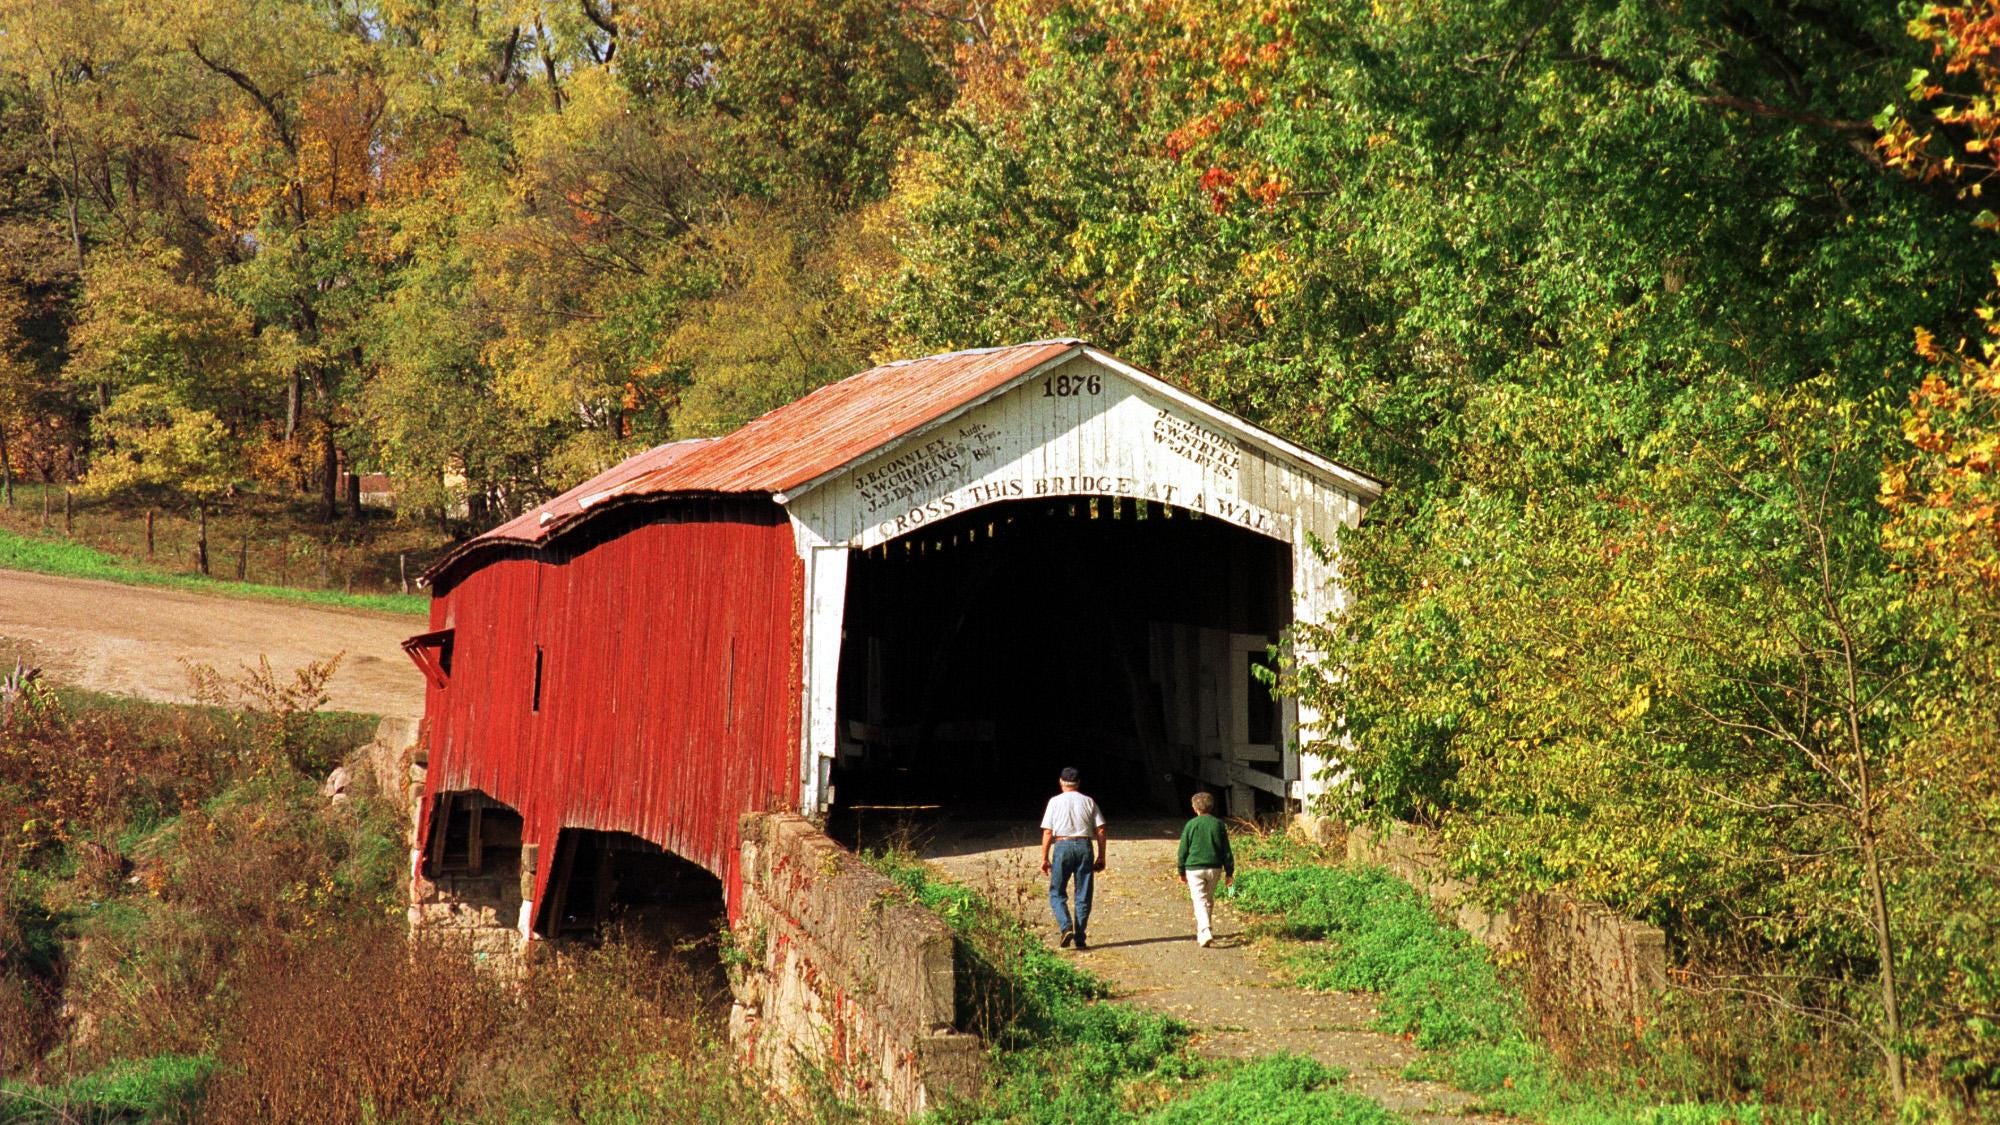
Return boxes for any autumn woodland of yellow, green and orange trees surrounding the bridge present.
[0,0,2000,1119]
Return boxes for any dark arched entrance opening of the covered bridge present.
[832,496,1296,843]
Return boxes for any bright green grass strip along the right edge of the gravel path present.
[1236,839,1830,1125]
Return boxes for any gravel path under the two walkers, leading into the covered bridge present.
[920,821,1500,1125]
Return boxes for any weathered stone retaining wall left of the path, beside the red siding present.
[730,813,984,1115]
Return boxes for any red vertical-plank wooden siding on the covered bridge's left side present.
[418,500,804,915]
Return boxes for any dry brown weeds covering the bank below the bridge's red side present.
[0,688,796,1125]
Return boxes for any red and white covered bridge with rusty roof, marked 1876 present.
[406,340,1382,937]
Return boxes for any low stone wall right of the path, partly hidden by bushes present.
[1348,823,1666,1021]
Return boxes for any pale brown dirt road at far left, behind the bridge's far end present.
[0,571,424,719]
